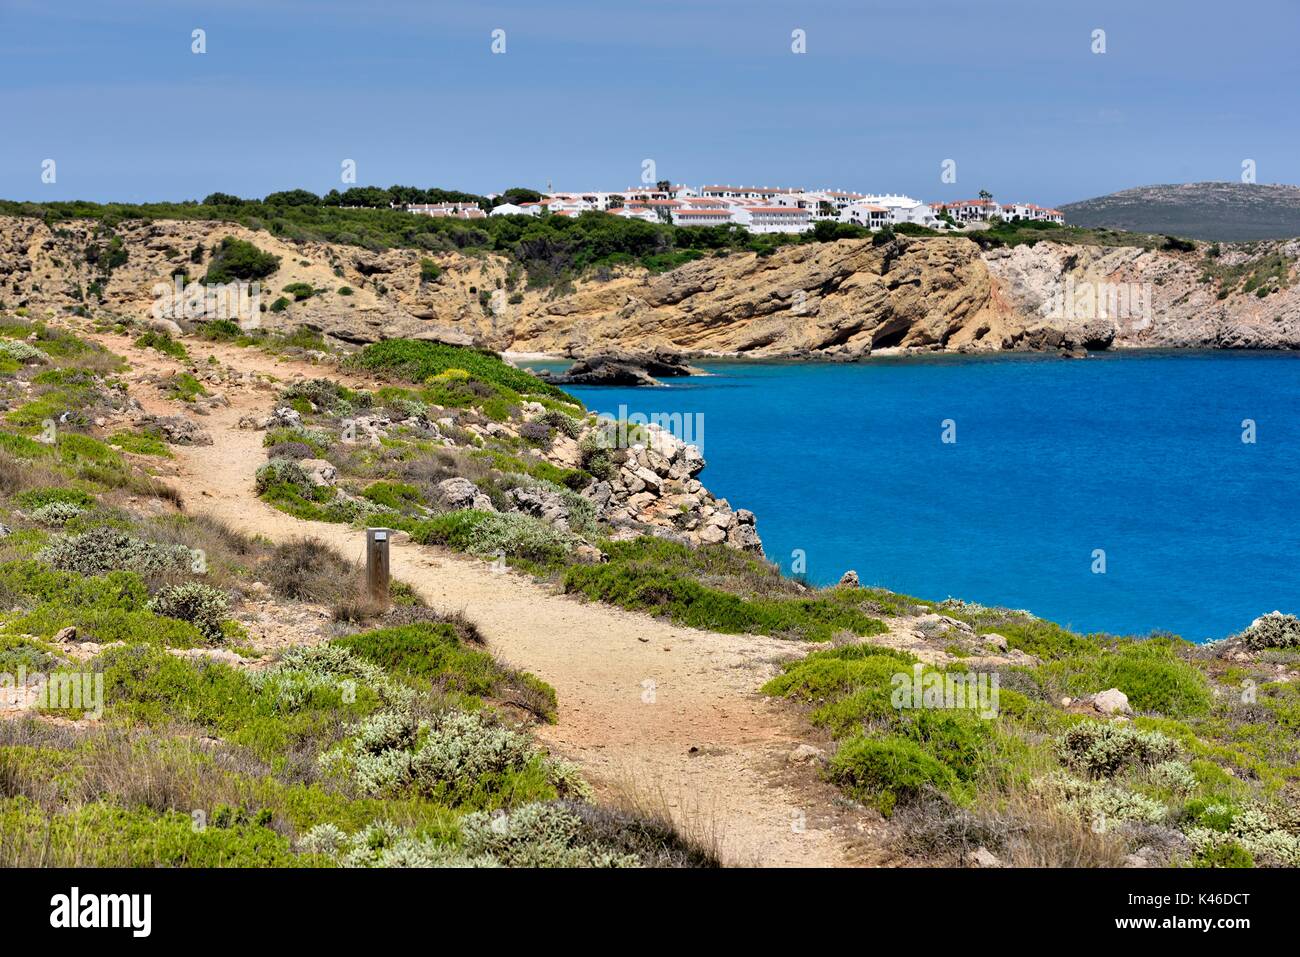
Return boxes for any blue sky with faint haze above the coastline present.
[0,0,1300,204]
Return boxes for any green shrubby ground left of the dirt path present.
[0,317,714,867]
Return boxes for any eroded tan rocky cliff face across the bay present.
[0,218,1300,358]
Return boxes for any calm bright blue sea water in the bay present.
[530,352,1300,640]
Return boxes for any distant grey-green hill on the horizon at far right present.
[1061,182,1300,242]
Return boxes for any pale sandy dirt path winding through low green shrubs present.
[95,335,879,866]
